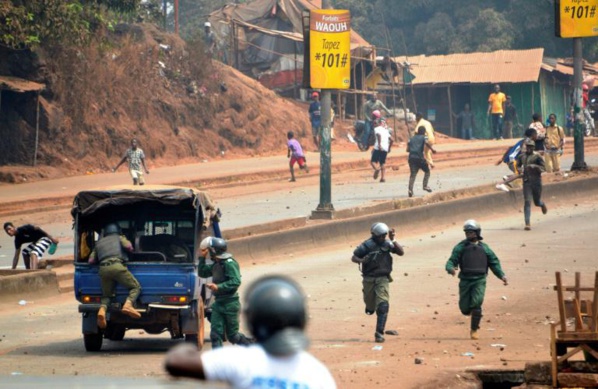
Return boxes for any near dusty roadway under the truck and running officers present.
[0,200,598,389]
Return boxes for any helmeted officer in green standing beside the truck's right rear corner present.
[197,238,251,348]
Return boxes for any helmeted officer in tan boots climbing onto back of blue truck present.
[89,223,141,329]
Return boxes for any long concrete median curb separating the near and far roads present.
[0,178,598,301]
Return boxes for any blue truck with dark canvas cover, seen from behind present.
[71,186,218,351]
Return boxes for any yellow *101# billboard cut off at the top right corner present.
[555,0,598,38]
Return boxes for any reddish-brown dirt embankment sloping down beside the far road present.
[0,25,402,183]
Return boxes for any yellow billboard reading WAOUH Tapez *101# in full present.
[309,9,351,89]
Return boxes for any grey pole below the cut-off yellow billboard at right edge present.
[571,38,588,170]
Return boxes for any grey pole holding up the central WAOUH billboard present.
[311,0,334,219]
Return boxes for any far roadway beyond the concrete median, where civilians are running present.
[0,139,598,268]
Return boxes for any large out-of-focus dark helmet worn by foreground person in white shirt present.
[244,275,308,355]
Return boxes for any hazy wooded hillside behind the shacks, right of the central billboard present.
[332,0,598,62]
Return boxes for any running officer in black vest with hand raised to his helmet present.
[351,223,404,343]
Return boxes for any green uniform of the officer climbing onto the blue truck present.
[89,235,141,308]
